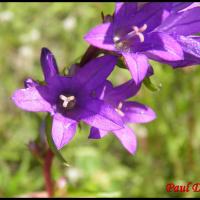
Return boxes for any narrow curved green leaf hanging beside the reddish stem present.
[45,114,69,167]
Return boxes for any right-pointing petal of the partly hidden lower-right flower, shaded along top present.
[122,102,156,123]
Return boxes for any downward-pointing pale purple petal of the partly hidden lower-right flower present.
[114,126,137,154]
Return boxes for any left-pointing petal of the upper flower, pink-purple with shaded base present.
[84,22,115,51]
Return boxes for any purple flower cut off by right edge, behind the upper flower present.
[156,2,200,68]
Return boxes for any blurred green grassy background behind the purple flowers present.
[0,3,200,197]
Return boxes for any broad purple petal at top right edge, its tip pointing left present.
[156,7,200,36]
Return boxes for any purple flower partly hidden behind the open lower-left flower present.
[89,80,156,154]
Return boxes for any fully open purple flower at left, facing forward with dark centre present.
[12,48,123,149]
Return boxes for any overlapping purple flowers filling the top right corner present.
[84,2,200,84]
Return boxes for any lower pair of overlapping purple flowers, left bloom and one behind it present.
[12,48,155,153]
